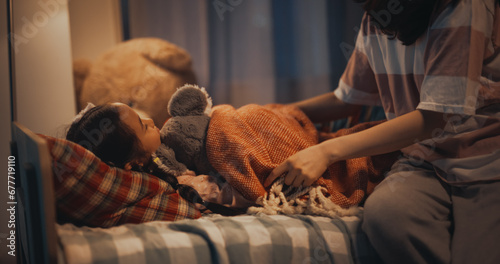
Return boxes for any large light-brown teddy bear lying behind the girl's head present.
[73,38,196,127]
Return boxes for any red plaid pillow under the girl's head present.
[40,135,201,227]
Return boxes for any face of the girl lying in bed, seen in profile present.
[113,103,161,157]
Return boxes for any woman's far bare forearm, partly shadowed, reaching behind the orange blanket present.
[292,93,361,123]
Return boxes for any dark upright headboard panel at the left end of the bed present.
[8,122,57,264]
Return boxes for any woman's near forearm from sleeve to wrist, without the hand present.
[318,110,444,163]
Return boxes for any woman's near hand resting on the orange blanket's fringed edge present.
[264,144,329,187]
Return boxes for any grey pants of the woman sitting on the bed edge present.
[363,159,500,263]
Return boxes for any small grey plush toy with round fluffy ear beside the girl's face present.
[156,85,214,176]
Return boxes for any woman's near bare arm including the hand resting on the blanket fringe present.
[265,110,445,186]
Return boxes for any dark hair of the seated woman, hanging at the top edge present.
[355,0,458,45]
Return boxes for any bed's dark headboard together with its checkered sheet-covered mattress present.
[7,122,380,264]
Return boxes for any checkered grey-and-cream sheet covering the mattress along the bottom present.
[57,215,379,264]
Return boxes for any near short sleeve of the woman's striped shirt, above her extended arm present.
[417,0,495,115]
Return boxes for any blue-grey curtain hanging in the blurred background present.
[127,0,362,107]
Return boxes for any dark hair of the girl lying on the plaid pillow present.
[66,104,147,168]
